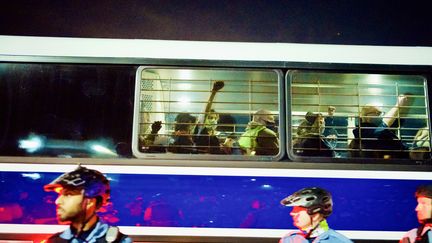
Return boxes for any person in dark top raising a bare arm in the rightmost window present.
[349,95,409,159]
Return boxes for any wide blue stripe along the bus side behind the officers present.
[0,172,426,231]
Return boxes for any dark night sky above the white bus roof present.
[0,0,432,46]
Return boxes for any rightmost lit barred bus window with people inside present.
[288,71,430,160]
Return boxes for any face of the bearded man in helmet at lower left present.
[55,188,84,222]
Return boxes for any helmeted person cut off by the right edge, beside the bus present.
[399,184,432,243]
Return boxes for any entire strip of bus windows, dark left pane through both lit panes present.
[0,63,430,164]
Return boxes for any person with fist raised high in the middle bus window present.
[194,81,225,154]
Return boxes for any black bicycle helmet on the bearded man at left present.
[44,166,110,205]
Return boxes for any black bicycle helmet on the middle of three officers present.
[281,187,333,217]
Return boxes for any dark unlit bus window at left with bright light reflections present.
[0,63,136,158]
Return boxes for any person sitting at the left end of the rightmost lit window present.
[293,112,336,157]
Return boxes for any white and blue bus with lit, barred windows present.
[0,36,432,242]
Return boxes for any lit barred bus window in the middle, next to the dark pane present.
[133,67,281,159]
